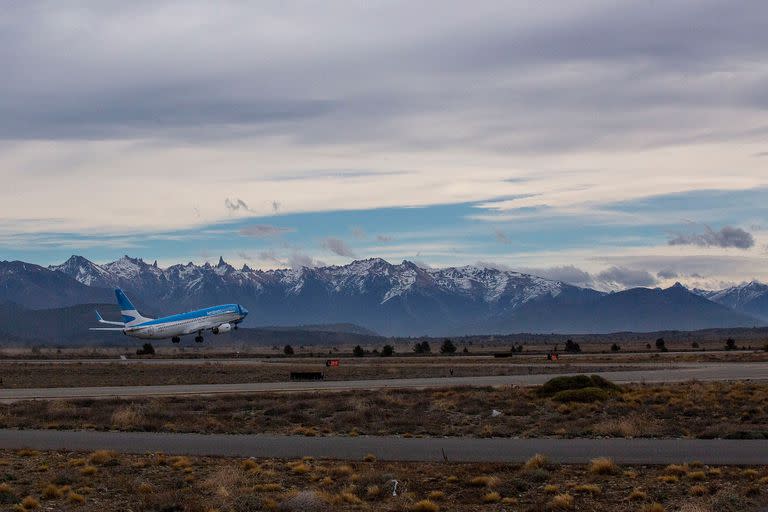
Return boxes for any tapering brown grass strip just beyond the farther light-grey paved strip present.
[0,358,628,388]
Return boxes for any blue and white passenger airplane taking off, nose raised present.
[90,288,248,343]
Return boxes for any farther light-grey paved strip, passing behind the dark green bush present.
[0,363,768,402]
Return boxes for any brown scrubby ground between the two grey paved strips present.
[6,382,768,439]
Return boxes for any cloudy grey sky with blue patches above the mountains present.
[0,0,768,290]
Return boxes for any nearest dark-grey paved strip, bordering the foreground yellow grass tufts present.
[0,430,768,465]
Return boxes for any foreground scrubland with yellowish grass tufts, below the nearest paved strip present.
[0,450,768,512]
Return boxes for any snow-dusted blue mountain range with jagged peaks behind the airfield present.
[0,256,768,336]
